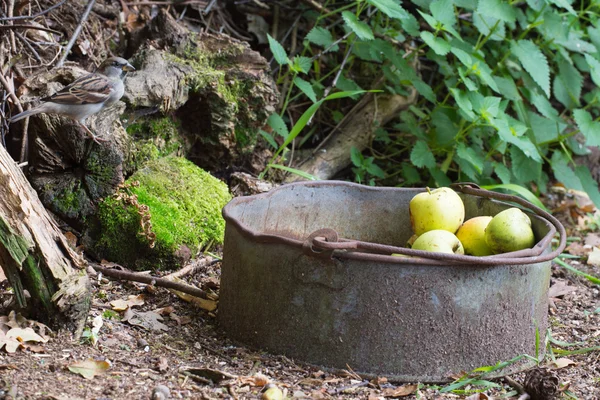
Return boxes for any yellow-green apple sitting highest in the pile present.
[408,188,465,235]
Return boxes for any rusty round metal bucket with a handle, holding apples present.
[219,181,566,382]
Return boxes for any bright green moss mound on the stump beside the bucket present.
[96,156,231,268]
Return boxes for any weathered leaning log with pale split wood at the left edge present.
[0,142,91,333]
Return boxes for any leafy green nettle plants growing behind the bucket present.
[269,0,600,205]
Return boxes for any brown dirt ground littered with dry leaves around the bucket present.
[0,200,600,399]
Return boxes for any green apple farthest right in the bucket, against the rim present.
[485,207,535,254]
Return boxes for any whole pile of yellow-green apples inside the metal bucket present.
[408,188,535,256]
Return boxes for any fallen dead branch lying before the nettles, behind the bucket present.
[288,89,417,181]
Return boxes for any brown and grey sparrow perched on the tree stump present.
[9,57,135,144]
